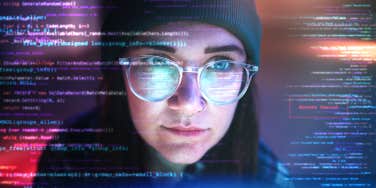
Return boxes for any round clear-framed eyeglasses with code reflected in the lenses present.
[119,55,258,105]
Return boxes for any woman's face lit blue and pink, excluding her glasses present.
[124,22,246,164]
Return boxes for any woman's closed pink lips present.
[161,125,209,137]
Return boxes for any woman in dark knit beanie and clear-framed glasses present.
[35,0,290,186]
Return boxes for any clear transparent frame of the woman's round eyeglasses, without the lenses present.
[118,55,259,105]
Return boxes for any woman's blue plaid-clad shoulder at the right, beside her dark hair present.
[256,141,294,188]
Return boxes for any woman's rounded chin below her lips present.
[160,144,207,164]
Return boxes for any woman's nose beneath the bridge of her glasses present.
[168,73,207,117]
